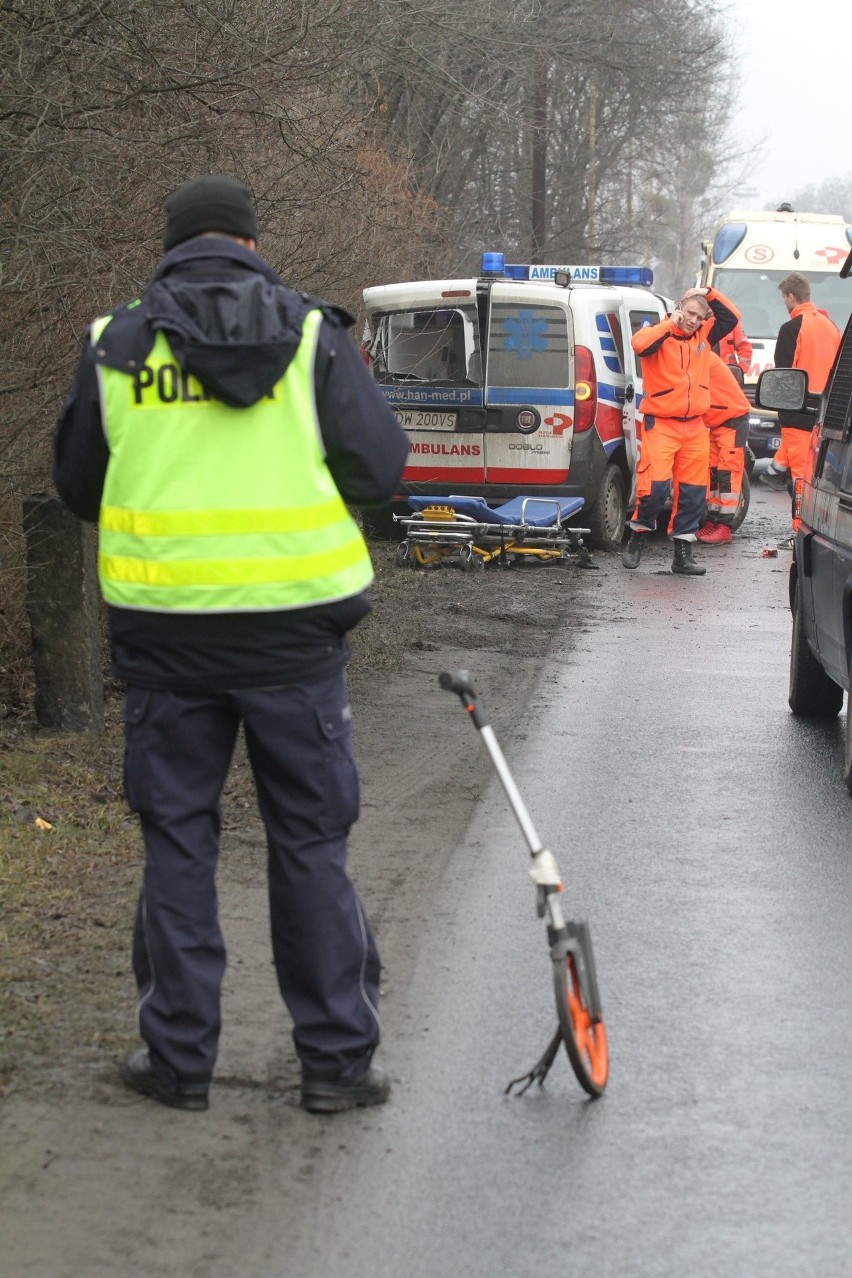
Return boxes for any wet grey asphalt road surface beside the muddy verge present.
[286,480,852,1278]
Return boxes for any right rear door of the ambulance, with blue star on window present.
[484,280,574,493]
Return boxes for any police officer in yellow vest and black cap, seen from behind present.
[54,176,407,1113]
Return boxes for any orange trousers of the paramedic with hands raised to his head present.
[630,417,710,538]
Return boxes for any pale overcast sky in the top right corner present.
[729,0,852,212]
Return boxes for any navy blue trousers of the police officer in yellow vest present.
[124,672,381,1082]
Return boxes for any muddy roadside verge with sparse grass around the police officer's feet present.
[0,502,779,1278]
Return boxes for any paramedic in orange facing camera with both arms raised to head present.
[622,288,740,576]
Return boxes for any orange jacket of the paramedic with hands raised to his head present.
[632,289,740,422]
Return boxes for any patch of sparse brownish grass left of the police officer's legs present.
[0,727,142,1091]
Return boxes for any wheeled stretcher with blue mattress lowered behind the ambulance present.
[393,495,593,571]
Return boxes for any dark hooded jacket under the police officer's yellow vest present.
[54,236,407,691]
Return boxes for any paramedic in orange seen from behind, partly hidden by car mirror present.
[763,271,841,546]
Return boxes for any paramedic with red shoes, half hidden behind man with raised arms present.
[695,353,751,546]
